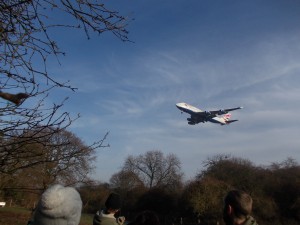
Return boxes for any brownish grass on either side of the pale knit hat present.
[0,207,93,225]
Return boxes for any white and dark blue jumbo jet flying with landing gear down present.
[176,102,243,125]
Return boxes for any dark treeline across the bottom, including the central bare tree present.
[0,151,300,225]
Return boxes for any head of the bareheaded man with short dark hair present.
[223,190,252,225]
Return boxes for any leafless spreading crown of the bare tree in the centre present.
[123,151,182,189]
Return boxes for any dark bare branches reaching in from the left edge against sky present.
[0,0,128,172]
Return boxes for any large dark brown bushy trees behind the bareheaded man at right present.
[183,155,300,224]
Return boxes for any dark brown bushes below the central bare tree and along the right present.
[76,155,300,225]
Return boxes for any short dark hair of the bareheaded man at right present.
[225,190,252,217]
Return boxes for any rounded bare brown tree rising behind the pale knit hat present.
[0,127,108,194]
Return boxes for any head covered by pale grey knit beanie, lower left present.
[33,184,82,225]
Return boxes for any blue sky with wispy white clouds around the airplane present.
[42,0,300,181]
